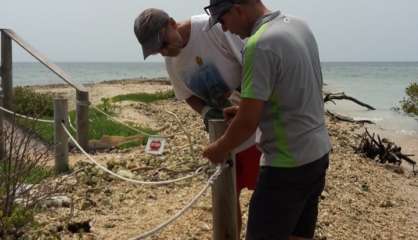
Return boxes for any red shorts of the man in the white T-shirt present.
[235,145,261,193]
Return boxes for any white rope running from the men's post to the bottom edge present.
[130,165,228,240]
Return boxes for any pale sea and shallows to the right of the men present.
[322,62,418,162]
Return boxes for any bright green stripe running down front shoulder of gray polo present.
[241,24,267,98]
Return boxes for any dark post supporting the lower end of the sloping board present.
[76,90,90,151]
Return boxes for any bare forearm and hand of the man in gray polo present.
[203,99,265,163]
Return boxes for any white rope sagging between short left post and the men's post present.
[61,123,204,185]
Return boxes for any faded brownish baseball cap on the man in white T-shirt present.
[134,8,170,59]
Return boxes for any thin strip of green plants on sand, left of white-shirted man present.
[112,90,175,103]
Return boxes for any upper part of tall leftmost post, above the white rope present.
[1,31,13,109]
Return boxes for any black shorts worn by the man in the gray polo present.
[246,154,329,240]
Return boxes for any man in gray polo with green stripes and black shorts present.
[203,0,331,240]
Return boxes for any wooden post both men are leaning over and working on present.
[209,120,240,240]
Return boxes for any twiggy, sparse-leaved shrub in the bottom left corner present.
[0,118,56,239]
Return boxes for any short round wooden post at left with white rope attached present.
[54,98,70,173]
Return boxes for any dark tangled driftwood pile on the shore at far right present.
[355,129,417,174]
